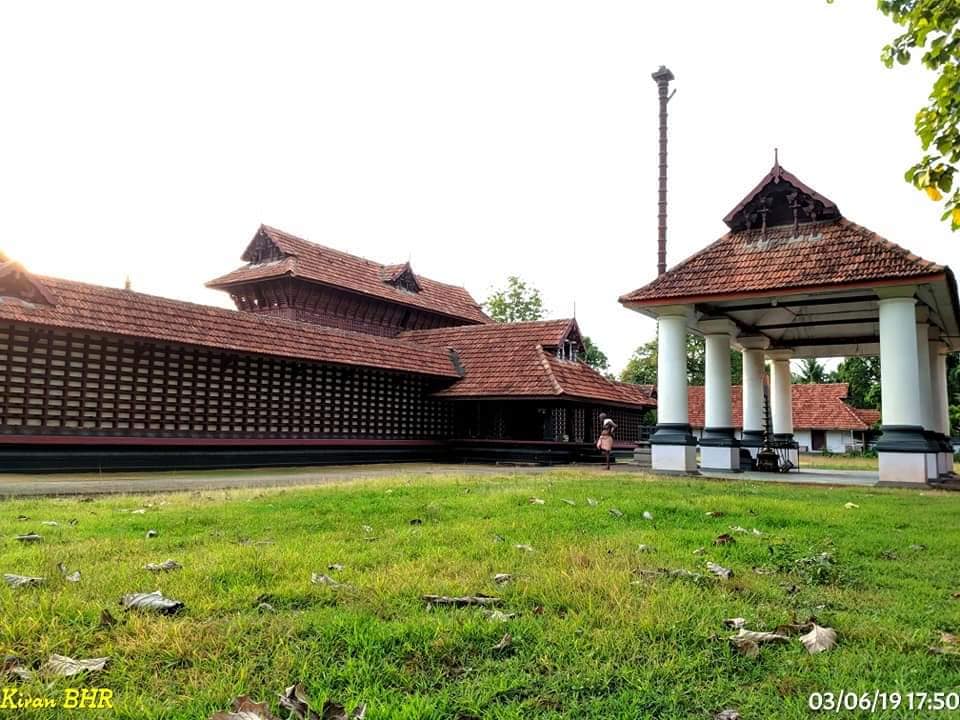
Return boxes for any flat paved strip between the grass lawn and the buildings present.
[0,463,892,497]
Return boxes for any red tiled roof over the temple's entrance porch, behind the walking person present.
[399,320,655,407]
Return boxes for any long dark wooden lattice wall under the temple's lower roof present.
[0,324,453,439]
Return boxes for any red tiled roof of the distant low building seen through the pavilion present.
[687,383,880,430]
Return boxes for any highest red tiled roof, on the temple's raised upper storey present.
[207,225,490,323]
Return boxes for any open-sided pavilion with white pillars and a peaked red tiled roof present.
[620,163,960,486]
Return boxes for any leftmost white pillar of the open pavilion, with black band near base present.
[650,306,697,472]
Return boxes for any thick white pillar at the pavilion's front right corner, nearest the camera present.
[877,287,929,485]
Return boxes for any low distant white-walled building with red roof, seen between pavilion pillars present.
[687,383,880,453]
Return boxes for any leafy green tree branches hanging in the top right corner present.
[877,0,960,230]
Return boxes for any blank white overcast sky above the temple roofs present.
[0,0,948,369]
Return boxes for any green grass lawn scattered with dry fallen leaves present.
[0,471,960,720]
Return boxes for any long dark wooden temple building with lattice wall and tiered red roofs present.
[0,226,655,470]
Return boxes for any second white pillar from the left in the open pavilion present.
[699,319,740,472]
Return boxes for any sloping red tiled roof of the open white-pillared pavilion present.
[620,218,945,305]
